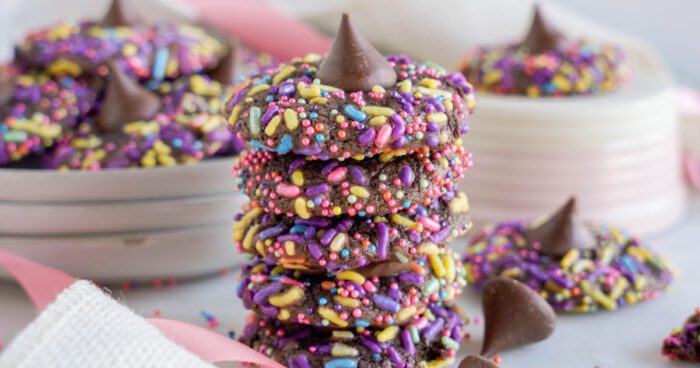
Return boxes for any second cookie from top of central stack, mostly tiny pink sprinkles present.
[234,143,471,217]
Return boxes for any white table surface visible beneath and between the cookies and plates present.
[0,194,700,368]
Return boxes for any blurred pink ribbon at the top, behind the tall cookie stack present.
[187,0,331,60]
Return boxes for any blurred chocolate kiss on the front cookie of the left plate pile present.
[95,61,161,132]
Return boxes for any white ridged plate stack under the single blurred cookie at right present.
[463,49,686,235]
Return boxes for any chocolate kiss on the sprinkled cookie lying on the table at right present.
[525,197,597,257]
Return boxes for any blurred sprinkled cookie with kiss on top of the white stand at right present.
[461,7,629,97]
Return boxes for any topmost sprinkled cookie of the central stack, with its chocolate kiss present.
[226,15,475,160]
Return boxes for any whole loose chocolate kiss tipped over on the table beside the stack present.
[481,277,556,358]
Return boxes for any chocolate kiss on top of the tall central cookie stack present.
[316,14,397,91]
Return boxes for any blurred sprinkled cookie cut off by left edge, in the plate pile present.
[0,71,100,166]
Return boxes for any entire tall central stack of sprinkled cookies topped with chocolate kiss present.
[226,15,475,368]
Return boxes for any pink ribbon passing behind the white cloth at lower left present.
[0,249,284,368]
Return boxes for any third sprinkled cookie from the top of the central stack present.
[233,192,470,274]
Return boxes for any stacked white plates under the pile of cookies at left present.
[0,159,249,282]
